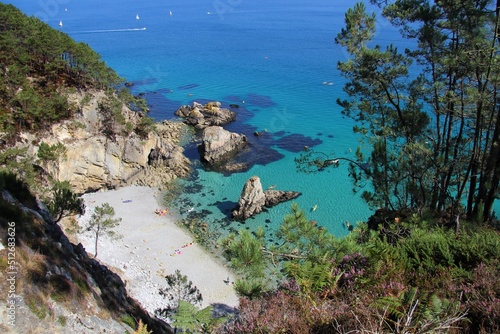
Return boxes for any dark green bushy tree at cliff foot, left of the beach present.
[47,181,85,222]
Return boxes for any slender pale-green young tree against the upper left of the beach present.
[83,203,122,257]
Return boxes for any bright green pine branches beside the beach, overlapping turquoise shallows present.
[222,204,355,298]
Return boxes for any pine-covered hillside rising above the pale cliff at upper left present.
[0,4,159,201]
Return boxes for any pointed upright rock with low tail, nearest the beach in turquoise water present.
[232,176,300,220]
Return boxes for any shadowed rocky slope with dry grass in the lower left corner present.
[0,175,171,334]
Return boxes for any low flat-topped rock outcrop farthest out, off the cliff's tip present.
[175,102,236,129]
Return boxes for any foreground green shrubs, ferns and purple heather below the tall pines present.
[219,205,500,333]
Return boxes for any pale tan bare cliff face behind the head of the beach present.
[18,92,190,193]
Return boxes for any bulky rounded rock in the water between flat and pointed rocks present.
[200,126,247,165]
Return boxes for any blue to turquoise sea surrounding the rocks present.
[6,0,498,240]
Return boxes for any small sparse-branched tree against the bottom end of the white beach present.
[155,269,203,318]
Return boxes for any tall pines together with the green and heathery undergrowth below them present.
[221,0,500,333]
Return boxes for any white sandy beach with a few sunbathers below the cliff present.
[78,186,238,313]
